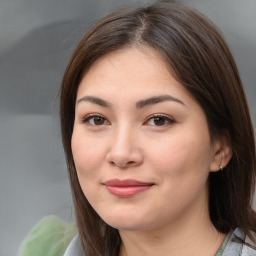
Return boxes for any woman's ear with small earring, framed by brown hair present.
[210,136,232,172]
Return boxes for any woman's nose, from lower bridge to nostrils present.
[106,126,143,169]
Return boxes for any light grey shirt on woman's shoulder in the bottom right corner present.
[222,228,256,256]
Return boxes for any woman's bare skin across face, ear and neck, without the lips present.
[72,47,232,256]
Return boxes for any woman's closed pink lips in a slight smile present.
[103,179,154,198]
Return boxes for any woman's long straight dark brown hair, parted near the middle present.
[60,3,256,256]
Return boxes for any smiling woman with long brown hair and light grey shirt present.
[20,0,256,256]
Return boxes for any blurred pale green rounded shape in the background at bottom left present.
[19,215,76,256]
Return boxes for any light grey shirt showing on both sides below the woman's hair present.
[64,228,256,256]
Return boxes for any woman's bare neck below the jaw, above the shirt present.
[119,186,225,256]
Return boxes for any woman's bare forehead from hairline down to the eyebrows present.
[77,47,201,113]
